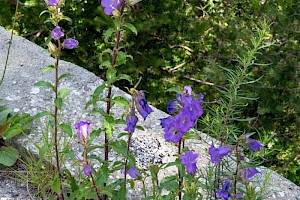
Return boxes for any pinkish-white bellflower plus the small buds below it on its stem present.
[74,121,93,177]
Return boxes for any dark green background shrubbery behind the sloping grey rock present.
[0,0,300,185]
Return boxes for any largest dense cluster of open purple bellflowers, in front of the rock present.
[160,86,204,143]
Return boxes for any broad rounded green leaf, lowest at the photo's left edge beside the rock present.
[0,146,19,167]
